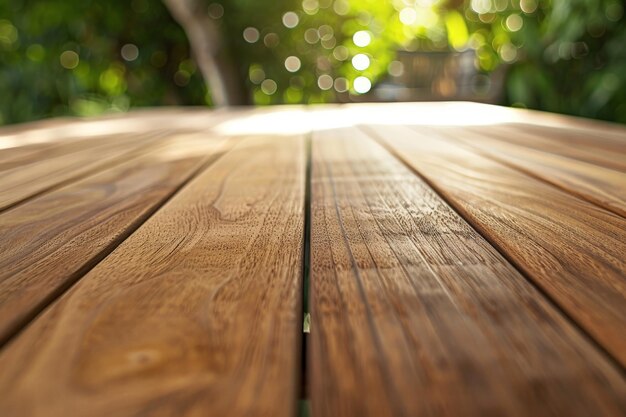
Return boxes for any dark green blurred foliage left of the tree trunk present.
[0,0,206,123]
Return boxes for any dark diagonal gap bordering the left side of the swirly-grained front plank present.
[0,139,232,349]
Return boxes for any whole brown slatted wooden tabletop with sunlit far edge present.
[0,103,626,417]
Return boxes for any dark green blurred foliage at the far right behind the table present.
[498,0,626,123]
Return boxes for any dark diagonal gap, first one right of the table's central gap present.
[355,125,626,377]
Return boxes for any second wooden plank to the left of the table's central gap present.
[0,134,228,344]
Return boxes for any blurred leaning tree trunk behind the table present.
[163,0,250,107]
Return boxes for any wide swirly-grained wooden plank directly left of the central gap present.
[0,136,305,417]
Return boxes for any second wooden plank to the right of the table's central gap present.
[370,126,626,365]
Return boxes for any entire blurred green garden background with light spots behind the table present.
[0,0,626,124]
